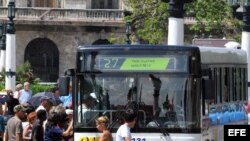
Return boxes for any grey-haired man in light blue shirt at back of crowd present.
[19,82,32,105]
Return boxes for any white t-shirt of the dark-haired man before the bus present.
[115,123,132,141]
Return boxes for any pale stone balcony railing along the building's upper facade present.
[0,7,195,25]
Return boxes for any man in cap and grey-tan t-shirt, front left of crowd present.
[5,105,26,141]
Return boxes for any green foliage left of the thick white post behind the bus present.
[125,0,169,44]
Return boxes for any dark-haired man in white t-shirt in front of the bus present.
[115,109,136,141]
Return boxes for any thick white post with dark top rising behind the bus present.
[162,0,192,45]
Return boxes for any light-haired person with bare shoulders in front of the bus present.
[96,116,113,141]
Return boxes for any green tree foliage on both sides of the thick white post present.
[125,0,241,44]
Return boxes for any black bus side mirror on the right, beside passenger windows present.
[202,79,215,99]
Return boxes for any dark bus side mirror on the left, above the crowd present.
[59,76,70,96]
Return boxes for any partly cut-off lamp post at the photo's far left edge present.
[0,24,6,72]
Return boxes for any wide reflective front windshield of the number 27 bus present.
[74,73,200,132]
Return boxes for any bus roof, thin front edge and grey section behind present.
[78,44,247,64]
